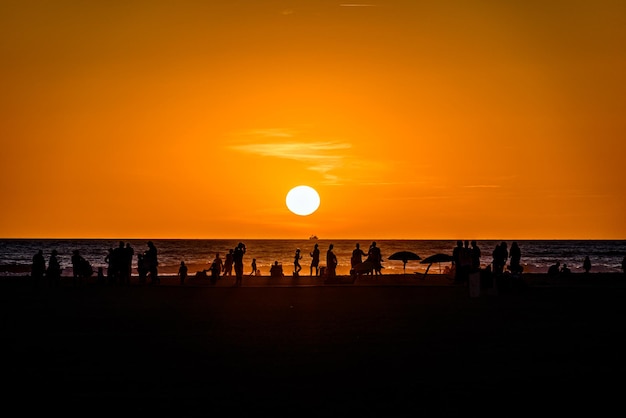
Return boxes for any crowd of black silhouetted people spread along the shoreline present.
[26,240,626,288]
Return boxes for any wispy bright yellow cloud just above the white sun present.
[229,128,352,184]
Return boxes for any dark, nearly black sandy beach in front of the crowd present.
[0,274,626,417]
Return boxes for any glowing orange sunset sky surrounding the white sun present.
[0,0,626,240]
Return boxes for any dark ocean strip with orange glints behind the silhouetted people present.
[0,239,626,276]
